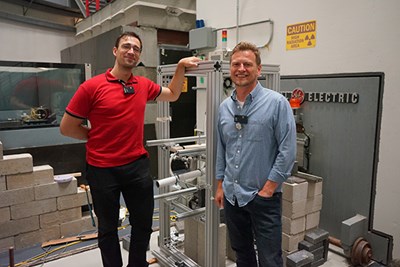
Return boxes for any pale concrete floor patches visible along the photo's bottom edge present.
[32,232,351,267]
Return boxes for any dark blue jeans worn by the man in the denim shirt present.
[224,193,283,267]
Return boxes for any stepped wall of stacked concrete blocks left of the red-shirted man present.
[0,142,95,252]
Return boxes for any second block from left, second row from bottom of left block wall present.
[39,207,82,229]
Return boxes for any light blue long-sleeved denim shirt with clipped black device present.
[216,83,296,207]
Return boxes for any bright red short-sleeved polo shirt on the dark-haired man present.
[66,69,161,167]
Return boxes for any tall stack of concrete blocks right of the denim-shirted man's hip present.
[282,173,322,261]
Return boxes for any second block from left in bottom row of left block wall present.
[15,225,61,249]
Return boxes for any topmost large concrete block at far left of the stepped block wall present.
[0,153,33,175]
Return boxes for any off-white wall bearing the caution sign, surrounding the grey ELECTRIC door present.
[196,0,400,258]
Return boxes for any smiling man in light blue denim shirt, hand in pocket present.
[215,42,296,267]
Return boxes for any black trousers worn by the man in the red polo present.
[86,157,154,267]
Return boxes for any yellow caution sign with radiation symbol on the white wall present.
[286,20,317,50]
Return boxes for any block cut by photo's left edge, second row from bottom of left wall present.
[0,216,39,238]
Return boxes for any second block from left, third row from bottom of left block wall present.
[11,198,57,220]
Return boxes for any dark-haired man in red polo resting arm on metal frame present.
[60,32,199,267]
